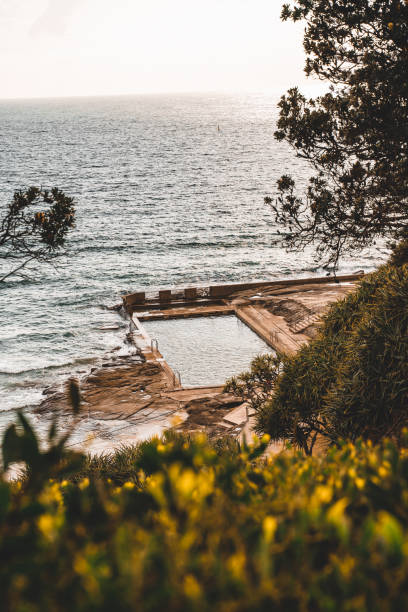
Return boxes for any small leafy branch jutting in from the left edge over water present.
[0,187,75,282]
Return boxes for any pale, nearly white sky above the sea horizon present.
[0,0,317,98]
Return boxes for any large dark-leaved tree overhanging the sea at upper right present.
[265,0,408,267]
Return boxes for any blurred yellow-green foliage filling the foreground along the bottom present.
[0,414,408,612]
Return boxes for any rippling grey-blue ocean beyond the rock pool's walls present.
[0,94,386,423]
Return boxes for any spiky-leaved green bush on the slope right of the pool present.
[257,265,408,453]
